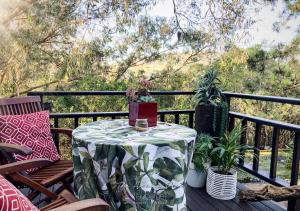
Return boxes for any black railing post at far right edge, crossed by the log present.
[288,132,300,211]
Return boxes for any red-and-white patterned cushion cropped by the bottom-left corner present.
[0,175,38,211]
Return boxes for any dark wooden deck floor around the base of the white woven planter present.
[186,184,286,211]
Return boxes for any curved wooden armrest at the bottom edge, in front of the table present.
[51,198,109,211]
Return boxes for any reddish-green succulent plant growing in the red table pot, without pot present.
[126,79,155,103]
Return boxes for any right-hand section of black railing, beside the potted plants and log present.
[225,93,300,211]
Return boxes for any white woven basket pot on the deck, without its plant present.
[206,167,237,200]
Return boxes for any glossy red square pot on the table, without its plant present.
[129,102,157,127]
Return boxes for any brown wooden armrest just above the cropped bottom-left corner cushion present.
[0,158,53,175]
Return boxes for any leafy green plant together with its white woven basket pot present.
[206,126,249,200]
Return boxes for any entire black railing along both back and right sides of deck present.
[28,91,300,210]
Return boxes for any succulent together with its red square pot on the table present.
[126,80,157,127]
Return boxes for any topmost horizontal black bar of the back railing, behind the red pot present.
[27,91,195,96]
